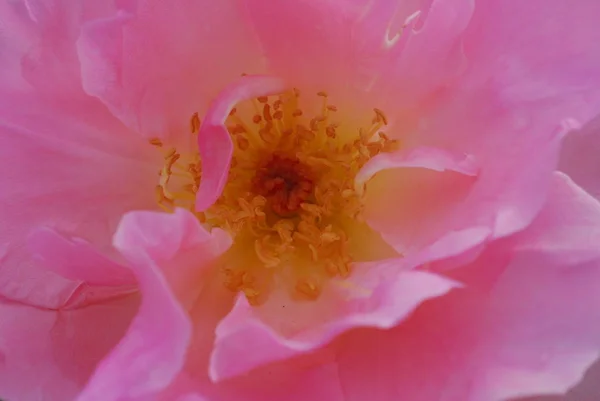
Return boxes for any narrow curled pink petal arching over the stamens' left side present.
[196,75,286,211]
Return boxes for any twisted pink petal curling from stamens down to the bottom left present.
[78,209,230,401]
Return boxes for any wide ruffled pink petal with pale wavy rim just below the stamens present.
[210,230,482,380]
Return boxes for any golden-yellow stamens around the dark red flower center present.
[150,90,397,304]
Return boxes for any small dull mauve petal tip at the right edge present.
[558,115,600,199]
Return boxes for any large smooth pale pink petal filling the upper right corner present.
[398,0,600,247]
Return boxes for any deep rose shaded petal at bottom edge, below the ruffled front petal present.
[334,290,480,401]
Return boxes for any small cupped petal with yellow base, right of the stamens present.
[356,147,478,253]
